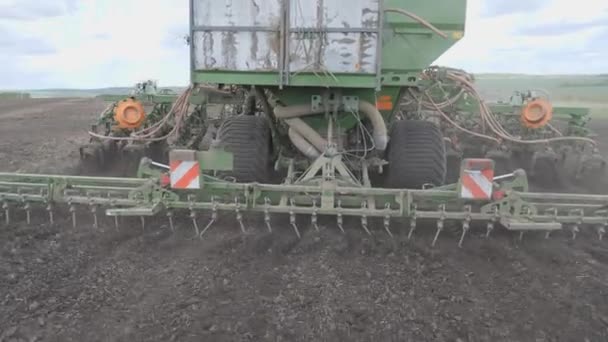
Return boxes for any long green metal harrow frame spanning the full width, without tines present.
[0,173,608,235]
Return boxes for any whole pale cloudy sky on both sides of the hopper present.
[0,0,608,89]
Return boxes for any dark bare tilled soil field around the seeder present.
[0,94,608,342]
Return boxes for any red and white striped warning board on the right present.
[460,159,494,200]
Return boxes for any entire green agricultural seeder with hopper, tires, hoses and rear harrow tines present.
[0,0,608,245]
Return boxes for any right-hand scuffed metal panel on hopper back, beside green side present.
[289,0,380,74]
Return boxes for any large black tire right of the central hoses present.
[385,120,447,189]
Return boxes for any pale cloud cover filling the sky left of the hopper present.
[0,0,189,88]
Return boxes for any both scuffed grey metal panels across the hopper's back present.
[192,0,380,74]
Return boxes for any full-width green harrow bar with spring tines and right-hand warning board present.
[0,160,608,246]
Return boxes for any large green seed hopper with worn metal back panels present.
[190,0,466,100]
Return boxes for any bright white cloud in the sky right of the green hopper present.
[436,0,608,74]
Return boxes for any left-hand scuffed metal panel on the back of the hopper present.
[192,0,283,71]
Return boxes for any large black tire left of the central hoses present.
[218,115,272,183]
